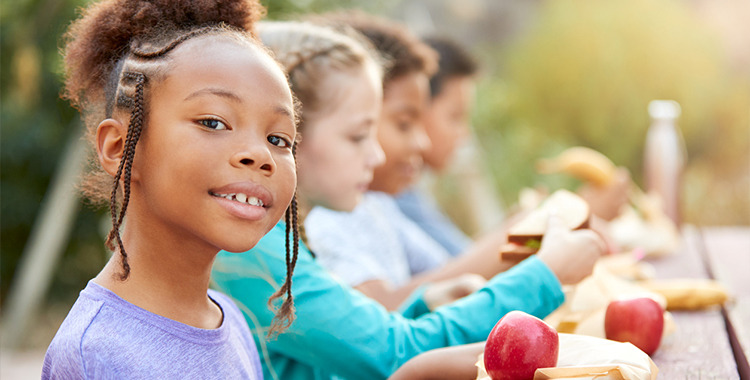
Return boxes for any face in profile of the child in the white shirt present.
[370,72,430,194]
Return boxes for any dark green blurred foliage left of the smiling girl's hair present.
[0,0,104,308]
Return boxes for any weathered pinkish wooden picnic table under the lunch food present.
[647,226,750,379]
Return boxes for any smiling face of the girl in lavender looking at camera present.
[128,36,296,252]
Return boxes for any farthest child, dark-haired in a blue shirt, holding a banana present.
[396,36,632,256]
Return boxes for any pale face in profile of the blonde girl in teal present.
[297,64,384,211]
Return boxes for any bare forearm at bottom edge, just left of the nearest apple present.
[388,342,484,380]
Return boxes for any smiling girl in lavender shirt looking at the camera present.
[42,0,296,379]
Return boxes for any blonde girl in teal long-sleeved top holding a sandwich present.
[212,17,598,380]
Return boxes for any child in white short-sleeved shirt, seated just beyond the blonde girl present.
[306,13,616,310]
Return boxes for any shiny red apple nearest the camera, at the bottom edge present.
[484,311,560,380]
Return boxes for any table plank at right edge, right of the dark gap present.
[701,227,750,378]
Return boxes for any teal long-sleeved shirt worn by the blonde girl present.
[212,223,564,380]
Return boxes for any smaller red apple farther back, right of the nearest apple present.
[604,297,664,355]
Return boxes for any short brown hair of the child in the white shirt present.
[308,10,438,85]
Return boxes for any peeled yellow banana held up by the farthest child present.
[537,146,617,186]
